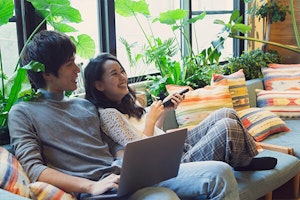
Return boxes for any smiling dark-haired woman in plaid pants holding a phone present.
[84,53,258,167]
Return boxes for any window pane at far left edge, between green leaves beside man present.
[0,22,19,77]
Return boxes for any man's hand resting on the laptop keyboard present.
[89,174,120,195]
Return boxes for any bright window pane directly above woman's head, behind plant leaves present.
[116,0,180,77]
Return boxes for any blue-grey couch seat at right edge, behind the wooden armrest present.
[263,120,300,159]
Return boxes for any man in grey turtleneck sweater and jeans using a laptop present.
[8,31,238,199]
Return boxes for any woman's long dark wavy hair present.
[84,53,145,119]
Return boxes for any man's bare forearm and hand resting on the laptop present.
[38,168,120,195]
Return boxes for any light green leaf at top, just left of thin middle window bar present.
[157,9,188,25]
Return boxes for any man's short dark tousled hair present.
[22,30,76,88]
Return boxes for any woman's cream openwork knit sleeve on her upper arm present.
[99,108,142,146]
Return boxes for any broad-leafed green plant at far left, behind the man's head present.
[0,0,95,144]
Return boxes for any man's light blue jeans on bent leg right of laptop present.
[156,161,239,200]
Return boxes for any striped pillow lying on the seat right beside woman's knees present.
[237,108,290,142]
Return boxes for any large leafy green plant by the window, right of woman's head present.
[115,0,224,96]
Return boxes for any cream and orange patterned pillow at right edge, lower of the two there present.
[255,89,300,119]
